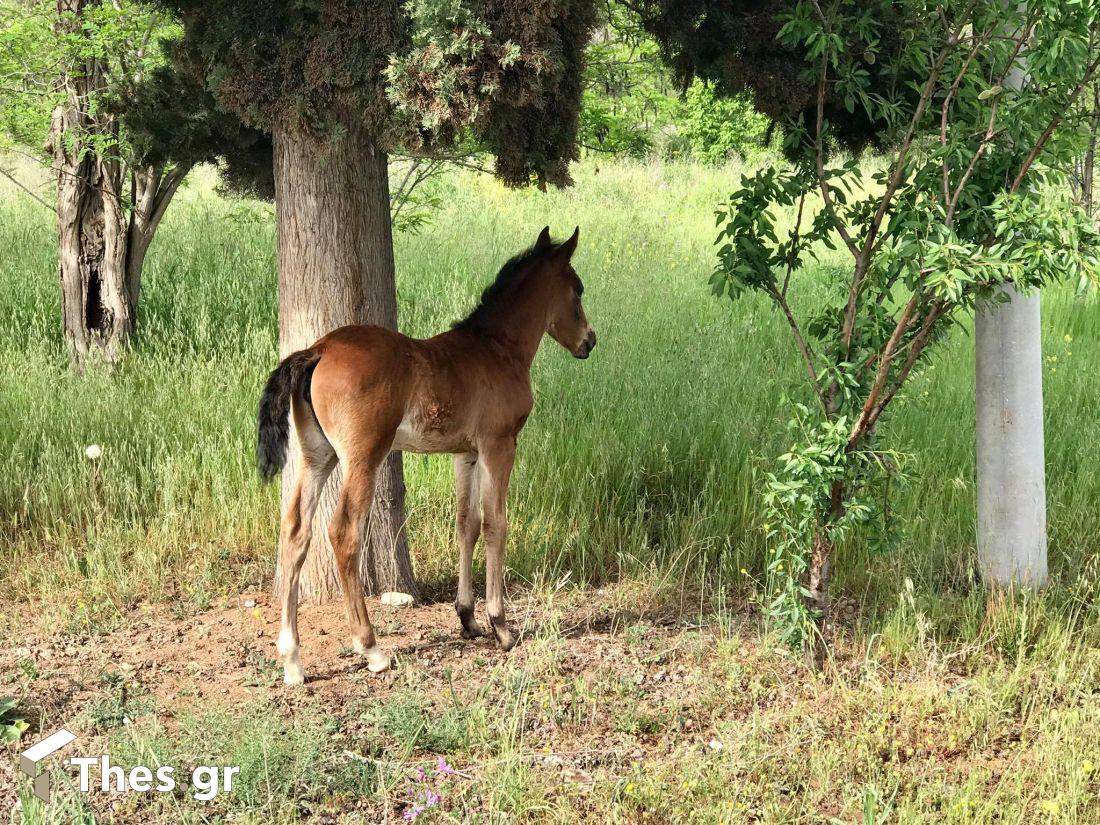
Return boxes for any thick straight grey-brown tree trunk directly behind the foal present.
[275,118,418,602]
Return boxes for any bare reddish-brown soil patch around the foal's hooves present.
[0,592,712,721]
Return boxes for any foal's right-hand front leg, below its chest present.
[479,437,516,650]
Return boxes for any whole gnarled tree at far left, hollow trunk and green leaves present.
[0,0,251,366]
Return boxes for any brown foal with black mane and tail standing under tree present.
[259,227,596,684]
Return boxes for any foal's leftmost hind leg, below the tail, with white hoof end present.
[276,409,337,684]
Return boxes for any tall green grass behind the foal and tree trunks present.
[0,163,1100,623]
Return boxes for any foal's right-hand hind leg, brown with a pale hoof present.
[329,450,389,673]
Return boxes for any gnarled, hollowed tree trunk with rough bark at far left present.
[44,0,188,366]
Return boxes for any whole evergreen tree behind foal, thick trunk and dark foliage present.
[152,0,593,601]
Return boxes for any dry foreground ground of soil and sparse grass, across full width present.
[0,585,1082,825]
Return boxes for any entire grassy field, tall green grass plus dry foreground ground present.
[0,163,1100,823]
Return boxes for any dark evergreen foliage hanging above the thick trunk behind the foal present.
[149,0,595,190]
